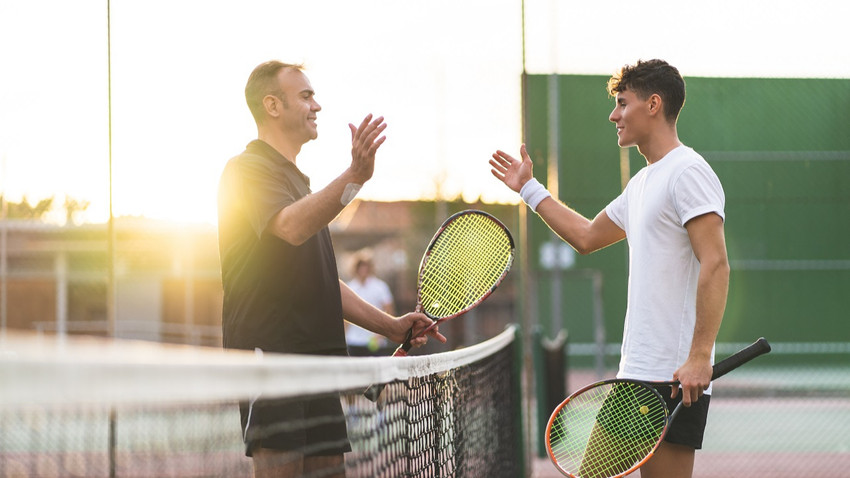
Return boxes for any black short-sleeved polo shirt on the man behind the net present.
[218,140,345,353]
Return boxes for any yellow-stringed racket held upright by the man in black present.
[364,209,514,401]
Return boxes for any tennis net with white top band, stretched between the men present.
[0,327,524,477]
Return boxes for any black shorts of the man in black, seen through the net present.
[239,350,351,456]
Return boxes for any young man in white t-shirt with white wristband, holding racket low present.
[490,60,729,478]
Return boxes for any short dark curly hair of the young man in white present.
[608,60,685,123]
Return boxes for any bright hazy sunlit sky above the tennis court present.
[0,0,850,223]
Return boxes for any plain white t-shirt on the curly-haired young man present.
[605,146,726,393]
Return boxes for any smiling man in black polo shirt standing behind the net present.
[218,61,446,477]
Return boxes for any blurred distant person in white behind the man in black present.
[345,251,395,357]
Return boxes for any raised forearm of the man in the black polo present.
[267,170,360,246]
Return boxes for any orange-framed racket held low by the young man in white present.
[546,338,770,478]
